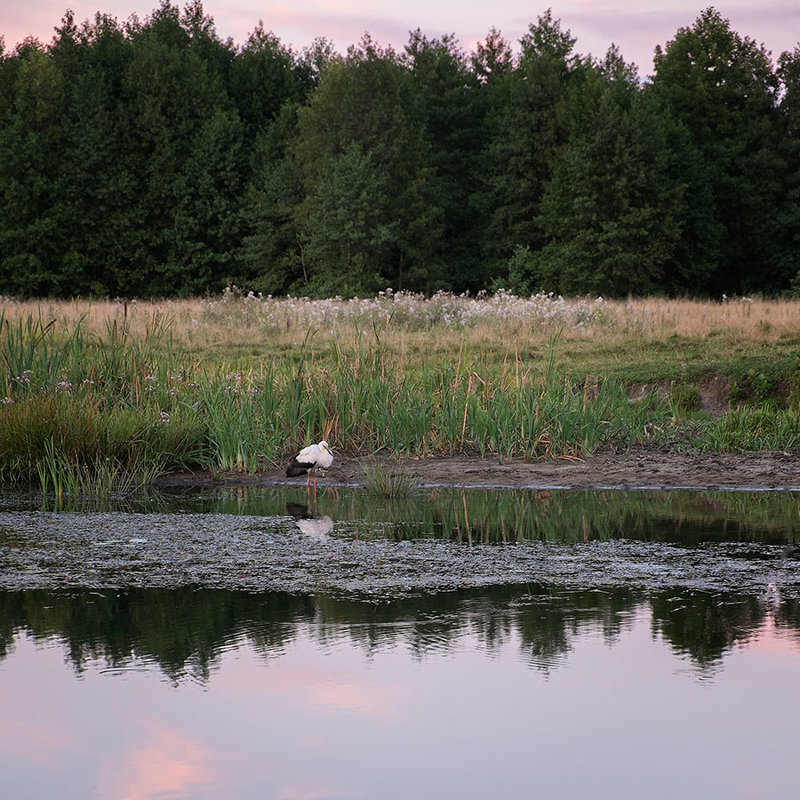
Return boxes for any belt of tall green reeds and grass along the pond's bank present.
[0,314,800,492]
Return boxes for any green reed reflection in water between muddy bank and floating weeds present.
[133,487,800,544]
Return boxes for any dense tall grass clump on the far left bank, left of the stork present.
[0,316,202,495]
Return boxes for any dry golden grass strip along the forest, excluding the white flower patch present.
[0,295,800,334]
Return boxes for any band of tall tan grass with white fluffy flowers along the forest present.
[0,287,800,351]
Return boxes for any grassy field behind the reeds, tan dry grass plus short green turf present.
[0,289,800,380]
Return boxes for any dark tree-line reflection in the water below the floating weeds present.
[0,587,800,681]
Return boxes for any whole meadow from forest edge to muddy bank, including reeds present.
[0,287,800,494]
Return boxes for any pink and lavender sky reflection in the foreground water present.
[0,605,800,800]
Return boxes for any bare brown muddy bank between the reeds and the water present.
[158,448,800,490]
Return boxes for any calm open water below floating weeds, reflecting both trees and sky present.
[0,587,800,800]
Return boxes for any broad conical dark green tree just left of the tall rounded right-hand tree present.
[530,50,682,296]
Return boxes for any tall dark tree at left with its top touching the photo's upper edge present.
[114,5,242,295]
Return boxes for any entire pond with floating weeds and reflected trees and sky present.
[0,488,800,800]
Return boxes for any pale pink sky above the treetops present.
[0,0,800,76]
